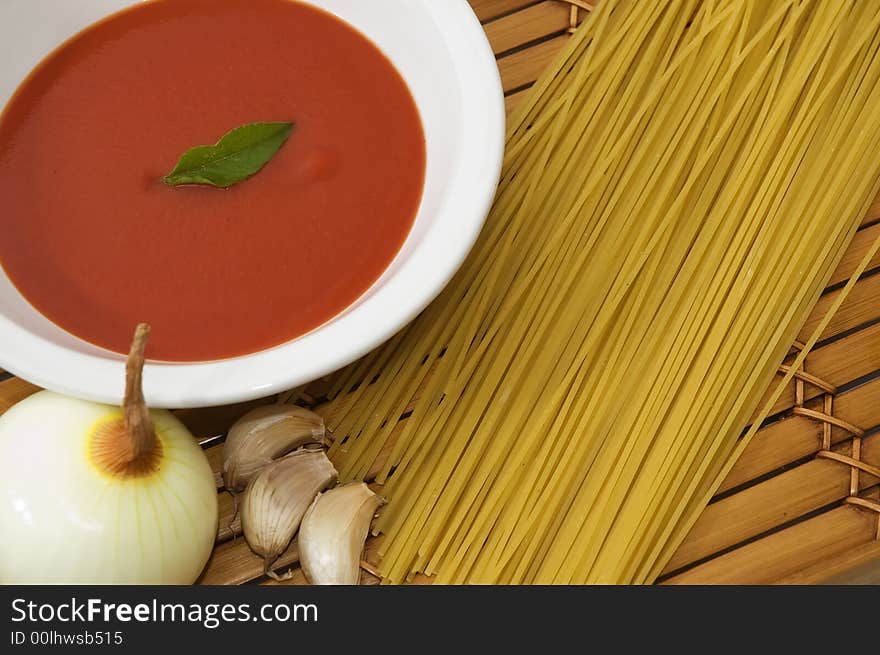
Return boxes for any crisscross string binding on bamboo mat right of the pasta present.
[779,342,880,540]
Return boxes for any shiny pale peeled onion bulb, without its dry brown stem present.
[0,391,217,584]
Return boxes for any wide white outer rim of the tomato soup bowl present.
[0,0,506,408]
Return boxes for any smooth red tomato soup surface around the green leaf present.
[0,0,425,361]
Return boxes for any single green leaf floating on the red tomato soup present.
[164,123,293,189]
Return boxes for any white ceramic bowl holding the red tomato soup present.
[0,0,504,407]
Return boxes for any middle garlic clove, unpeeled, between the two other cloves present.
[241,449,337,577]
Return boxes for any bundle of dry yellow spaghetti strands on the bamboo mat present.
[326,0,880,583]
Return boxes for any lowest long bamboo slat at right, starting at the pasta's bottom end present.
[664,489,878,585]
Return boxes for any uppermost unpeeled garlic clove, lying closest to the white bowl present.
[223,405,324,492]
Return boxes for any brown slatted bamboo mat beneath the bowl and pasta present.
[0,0,880,584]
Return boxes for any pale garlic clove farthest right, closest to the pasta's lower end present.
[297,482,385,585]
